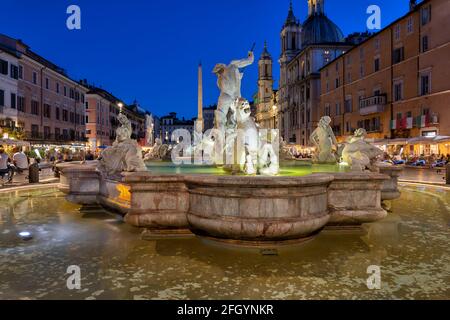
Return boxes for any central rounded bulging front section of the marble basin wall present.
[186,174,333,243]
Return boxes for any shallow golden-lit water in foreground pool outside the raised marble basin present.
[0,186,450,299]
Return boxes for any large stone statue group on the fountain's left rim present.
[98,113,147,176]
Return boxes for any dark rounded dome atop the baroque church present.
[302,14,344,46]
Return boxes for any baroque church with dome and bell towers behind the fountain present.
[257,0,353,146]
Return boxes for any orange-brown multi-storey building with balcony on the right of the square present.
[320,0,450,148]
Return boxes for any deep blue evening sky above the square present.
[0,0,408,118]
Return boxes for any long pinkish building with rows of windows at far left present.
[0,34,88,144]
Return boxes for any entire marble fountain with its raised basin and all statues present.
[56,52,399,245]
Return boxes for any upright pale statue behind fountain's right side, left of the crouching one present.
[310,116,339,164]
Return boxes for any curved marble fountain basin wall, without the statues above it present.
[59,163,398,244]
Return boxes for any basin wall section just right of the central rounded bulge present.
[328,173,389,226]
